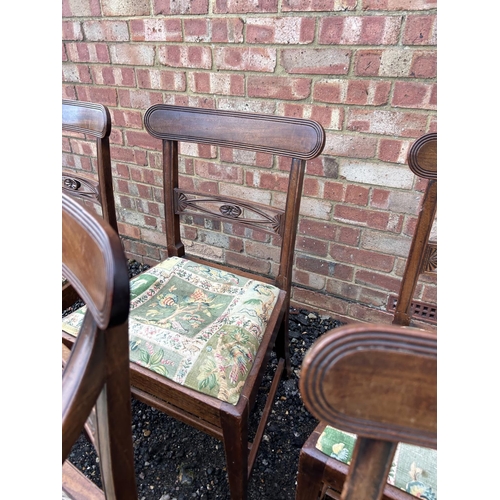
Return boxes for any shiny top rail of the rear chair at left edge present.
[62,99,111,139]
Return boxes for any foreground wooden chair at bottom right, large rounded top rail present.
[296,324,437,500]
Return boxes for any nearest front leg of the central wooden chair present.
[221,401,248,500]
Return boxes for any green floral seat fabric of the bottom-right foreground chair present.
[316,426,437,500]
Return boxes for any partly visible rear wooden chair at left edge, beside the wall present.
[62,100,118,310]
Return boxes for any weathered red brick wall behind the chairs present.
[62,0,437,330]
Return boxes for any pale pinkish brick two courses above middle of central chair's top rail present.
[214,47,276,72]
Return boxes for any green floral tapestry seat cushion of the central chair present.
[62,257,280,404]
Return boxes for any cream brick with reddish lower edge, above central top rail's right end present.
[281,47,351,75]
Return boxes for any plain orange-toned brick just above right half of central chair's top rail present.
[247,76,311,101]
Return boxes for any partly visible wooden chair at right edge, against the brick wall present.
[392,133,437,326]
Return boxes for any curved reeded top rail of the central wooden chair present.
[144,104,325,160]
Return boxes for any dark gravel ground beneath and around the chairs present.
[63,261,341,500]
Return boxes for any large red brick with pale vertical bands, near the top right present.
[318,15,401,45]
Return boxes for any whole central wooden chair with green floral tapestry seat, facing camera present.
[64,104,325,500]
